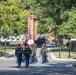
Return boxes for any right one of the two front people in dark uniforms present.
[23,44,32,68]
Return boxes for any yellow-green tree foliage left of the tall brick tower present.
[0,0,29,37]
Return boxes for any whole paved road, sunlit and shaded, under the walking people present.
[0,48,76,75]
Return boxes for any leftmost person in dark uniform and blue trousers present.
[15,44,23,68]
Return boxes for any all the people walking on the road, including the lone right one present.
[15,40,47,68]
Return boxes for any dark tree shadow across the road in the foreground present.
[0,63,76,75]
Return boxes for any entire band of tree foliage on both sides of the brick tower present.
[0,0,76,38]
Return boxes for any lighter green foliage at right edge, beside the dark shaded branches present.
[60,7,76,37]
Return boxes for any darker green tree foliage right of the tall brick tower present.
[32,0,76,38]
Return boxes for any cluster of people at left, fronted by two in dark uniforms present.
[15,42,36,68]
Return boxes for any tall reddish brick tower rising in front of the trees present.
[28,13,38,40]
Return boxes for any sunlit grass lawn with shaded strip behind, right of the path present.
[51,47,76,59]
